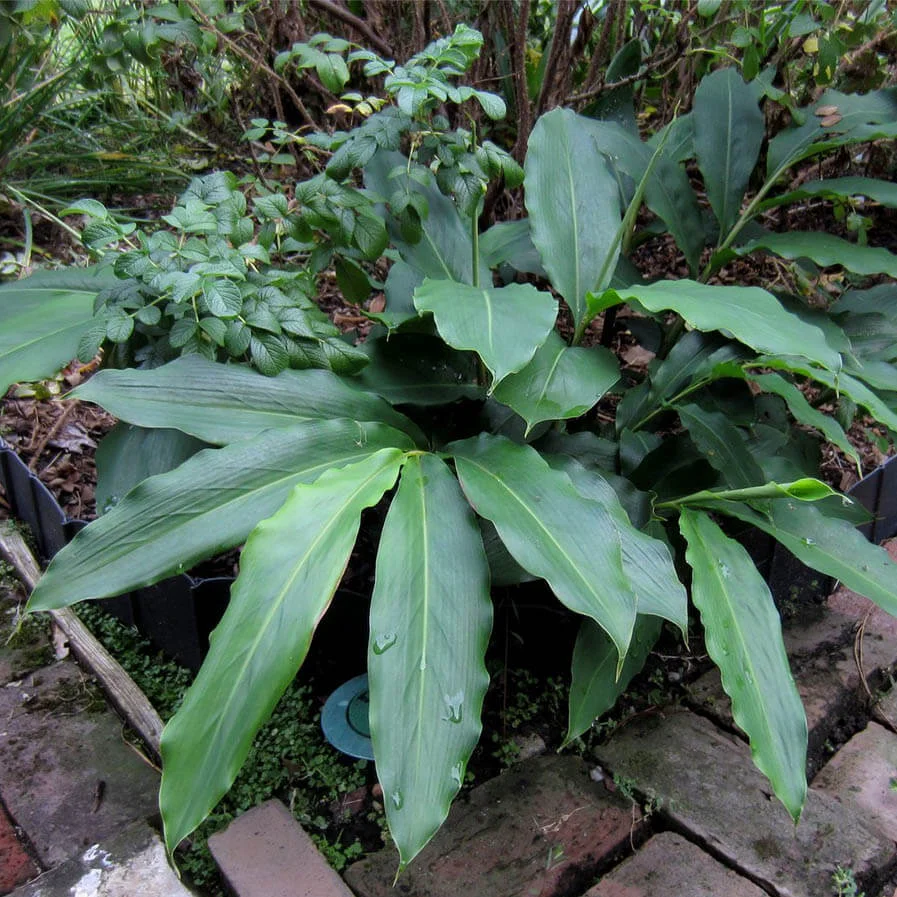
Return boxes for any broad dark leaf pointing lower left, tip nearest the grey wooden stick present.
[29,420,414,610]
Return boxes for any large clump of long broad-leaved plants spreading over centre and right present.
[21,35,897,880]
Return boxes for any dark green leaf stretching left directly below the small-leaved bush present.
[73,355,423,445]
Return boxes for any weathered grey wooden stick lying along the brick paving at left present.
[0,526,162,759]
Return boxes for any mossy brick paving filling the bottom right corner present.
[338,542,897,897]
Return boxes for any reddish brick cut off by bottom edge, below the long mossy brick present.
[585,832,766,897]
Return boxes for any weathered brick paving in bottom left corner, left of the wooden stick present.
[0,591,189,897]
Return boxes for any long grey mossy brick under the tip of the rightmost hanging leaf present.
[595,710,897,897]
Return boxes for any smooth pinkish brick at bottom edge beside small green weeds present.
[209,800,352,897]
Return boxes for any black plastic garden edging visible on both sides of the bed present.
[0,430,897,670]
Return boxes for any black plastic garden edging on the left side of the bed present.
[0,439,233,670]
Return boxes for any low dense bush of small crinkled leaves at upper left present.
[69,173,370,376]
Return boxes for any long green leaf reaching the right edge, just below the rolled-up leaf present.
[705,500,897,616]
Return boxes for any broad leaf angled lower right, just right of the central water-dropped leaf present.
[447,434,636,663]
